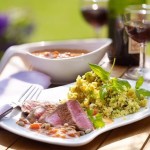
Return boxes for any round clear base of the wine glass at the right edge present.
[125,67,150,80]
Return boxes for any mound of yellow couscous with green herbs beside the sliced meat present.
[68,65,147,119]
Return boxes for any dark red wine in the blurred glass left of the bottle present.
[81,7,108,27]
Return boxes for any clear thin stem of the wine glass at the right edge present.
[139,43,146,68]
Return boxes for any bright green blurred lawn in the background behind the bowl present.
[0,0,107,42]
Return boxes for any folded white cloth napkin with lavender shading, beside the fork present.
[0,71,51,104]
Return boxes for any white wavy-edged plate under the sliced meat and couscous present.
[0,80,150,147]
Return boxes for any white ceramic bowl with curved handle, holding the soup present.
[0,39,112,84]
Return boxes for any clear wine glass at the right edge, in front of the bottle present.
[124,4,150,80]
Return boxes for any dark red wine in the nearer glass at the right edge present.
[125,21,150,43]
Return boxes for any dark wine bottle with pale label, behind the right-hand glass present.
[108,0,147,66]
